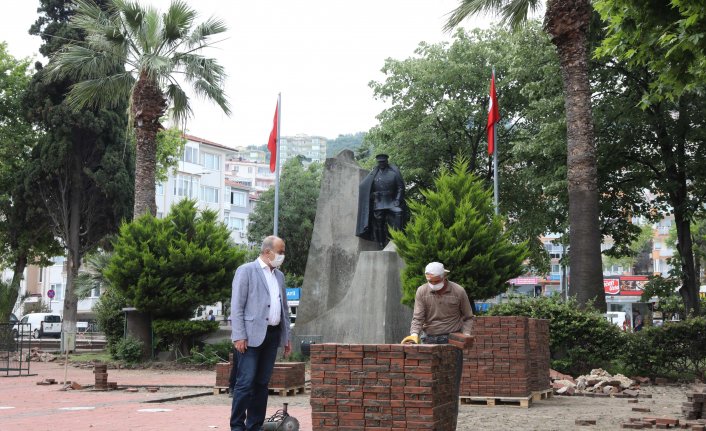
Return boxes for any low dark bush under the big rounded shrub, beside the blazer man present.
[152,319,218,355]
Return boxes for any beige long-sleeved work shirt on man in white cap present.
[409,281,473,335]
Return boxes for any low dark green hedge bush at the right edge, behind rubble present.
[620,317,706,380]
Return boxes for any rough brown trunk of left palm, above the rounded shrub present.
[131,74,166,218]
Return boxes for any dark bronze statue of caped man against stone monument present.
[355,154,407,250]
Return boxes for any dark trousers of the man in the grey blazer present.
[230,326,281,431]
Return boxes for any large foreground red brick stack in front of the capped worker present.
[310,344,458,431]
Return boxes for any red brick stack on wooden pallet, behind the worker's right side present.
[461,316,551,397]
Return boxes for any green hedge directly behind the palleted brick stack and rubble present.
[488,295,625,375]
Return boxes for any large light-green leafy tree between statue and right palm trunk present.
[366,22,567,272]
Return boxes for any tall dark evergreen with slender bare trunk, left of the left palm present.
[25,0,133,350]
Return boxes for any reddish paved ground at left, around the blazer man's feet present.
[0,363,311,431]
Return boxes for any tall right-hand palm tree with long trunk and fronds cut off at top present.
[446,0,606,311]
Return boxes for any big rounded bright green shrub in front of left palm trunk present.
[104,200,244,319]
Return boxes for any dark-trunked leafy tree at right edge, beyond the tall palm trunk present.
[594,26,706,314]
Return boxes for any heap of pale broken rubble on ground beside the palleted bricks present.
[552,368,647,398]
